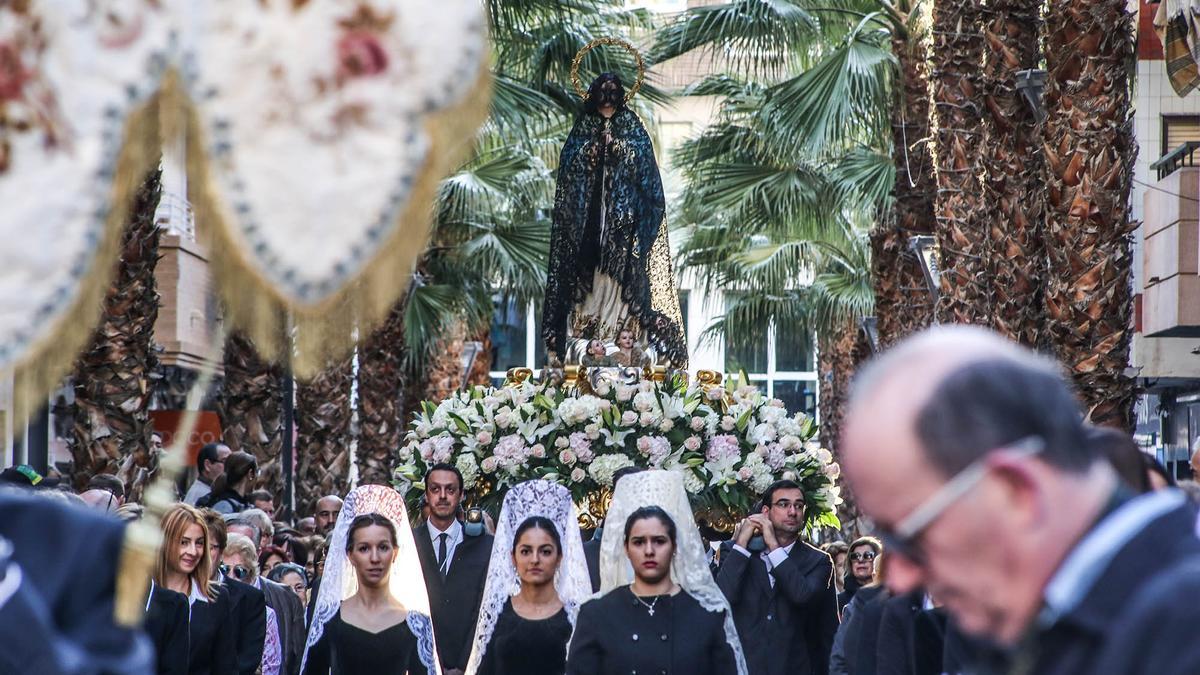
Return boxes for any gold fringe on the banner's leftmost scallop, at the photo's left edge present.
[12,90,162,428]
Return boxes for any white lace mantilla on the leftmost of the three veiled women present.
[300,485,442,674]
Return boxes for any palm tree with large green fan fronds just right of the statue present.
[652,1,892,446]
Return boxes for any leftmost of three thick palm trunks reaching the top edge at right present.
[932,0,992,325]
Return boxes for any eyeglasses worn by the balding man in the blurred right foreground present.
[877,436,1045,563]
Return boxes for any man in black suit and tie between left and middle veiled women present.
[413,464,492,675]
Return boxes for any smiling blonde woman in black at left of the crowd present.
[154,504,236,675]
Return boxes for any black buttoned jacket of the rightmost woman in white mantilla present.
[566,586,737,675]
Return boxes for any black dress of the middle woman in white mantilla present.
[479,601,571,675]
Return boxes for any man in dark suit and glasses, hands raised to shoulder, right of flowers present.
[716,480,838,675]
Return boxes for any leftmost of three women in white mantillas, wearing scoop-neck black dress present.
[302,485,437,675]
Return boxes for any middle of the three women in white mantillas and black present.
[467,480,592,675]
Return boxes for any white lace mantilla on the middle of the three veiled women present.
[467,480,592,675]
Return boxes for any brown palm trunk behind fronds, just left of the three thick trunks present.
[871,26,936,346]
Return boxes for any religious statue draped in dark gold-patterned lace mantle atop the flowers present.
[542,73,688,368]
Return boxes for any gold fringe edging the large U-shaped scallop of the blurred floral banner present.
[176,61,492,380]
